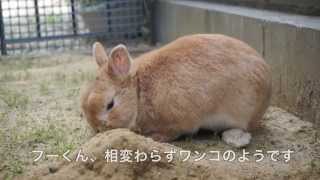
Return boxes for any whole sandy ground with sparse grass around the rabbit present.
[0,53,320,180]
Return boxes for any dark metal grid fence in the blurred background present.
[0,0,145,55]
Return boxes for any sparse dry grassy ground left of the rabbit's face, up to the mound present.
[0,54,95,179]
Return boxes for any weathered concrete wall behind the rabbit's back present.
[155,0,320,126]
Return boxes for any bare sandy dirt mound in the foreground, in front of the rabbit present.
[17,108,320,180]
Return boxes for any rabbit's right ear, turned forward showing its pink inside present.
[108,44,131,78]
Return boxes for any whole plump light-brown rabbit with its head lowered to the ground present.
[82,34,271,147]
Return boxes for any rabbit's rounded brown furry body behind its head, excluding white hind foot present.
[134,34,271,135]
